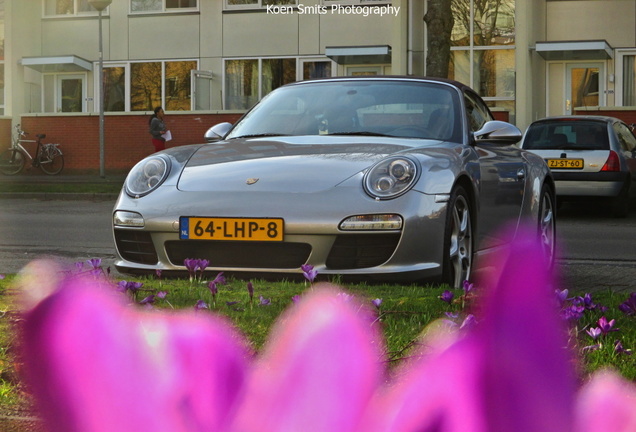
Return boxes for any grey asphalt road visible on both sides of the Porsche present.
[0,199,636,292]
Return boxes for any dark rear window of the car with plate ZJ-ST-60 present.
[523,120,609,150]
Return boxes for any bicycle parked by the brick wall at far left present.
[0,125,64,175]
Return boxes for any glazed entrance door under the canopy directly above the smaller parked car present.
[565,63,605,115]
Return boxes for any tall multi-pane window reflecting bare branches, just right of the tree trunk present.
[449,0,516,119]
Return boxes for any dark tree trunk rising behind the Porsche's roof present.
[424,0,453,78]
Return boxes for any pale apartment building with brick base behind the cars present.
[0,0,636,174]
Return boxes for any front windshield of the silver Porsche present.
[227,80,462,142]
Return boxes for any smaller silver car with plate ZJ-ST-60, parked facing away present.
[521,116,636,217]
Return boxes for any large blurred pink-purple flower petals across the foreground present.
[17,226,636,432]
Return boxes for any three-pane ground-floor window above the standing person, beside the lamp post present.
[104,60,198,112]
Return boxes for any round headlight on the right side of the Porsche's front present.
[364,156,419,199]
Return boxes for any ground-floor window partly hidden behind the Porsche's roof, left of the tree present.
[224,57,335,110]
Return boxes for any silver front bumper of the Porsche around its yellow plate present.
[114,186,446,281]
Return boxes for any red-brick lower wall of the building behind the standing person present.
[13,113,246,174]
